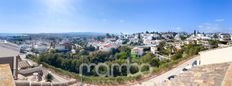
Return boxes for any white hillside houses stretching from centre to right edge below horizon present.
[85,31,232,56]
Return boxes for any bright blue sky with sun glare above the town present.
[0,0,232,33]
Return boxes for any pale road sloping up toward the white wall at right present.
[132,56,200,86]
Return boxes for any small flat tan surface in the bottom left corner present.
[0,64,15,86]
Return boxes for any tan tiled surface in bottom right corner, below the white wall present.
[164,63,232,86]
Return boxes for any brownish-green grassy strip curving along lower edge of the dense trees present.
[38,54,198,84]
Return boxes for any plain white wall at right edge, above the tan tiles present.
[200,47,232,65]
